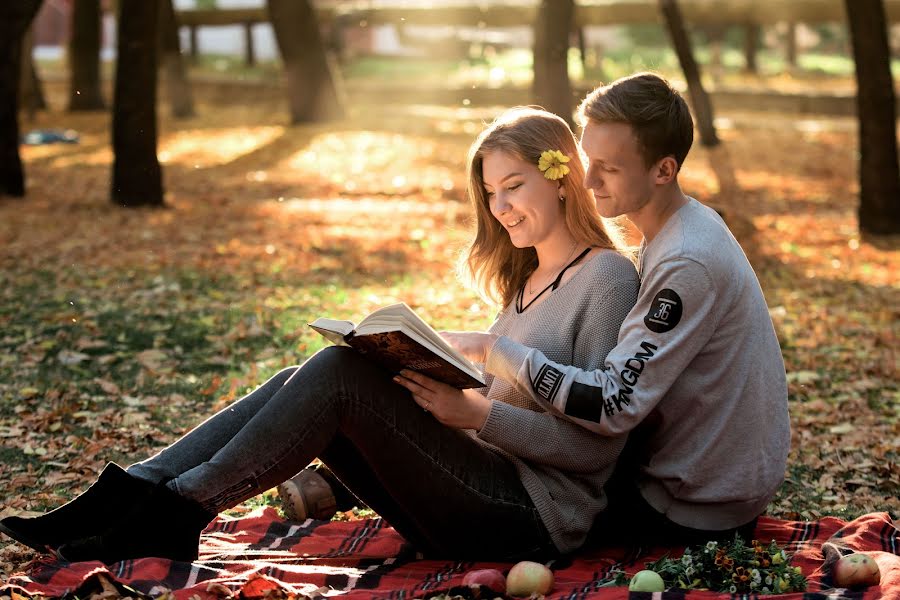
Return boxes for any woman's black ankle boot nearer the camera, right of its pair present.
[56,484,216,564]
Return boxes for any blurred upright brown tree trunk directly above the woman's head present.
[532,0,575,126]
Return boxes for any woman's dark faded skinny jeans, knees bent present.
[128,347,556,560]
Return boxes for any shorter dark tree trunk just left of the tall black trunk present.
[69,0,105,111]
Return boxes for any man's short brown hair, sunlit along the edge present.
[578,73,694,169]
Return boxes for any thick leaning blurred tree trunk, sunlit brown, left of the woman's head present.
[267,0,344,123]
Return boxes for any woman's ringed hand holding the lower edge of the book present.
[394,369,491,430]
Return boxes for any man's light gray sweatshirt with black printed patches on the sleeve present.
[486,199,790,530]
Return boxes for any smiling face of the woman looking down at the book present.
[481,151,566,248]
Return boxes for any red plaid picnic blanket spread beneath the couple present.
[0,508,900,600]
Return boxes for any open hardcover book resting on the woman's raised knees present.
[309,302,484,389]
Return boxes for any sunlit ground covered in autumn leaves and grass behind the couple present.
[0,88,900,574]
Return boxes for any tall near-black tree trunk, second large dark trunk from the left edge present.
[111,0,163,207]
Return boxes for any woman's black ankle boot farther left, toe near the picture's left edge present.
[0,463,154,552]
